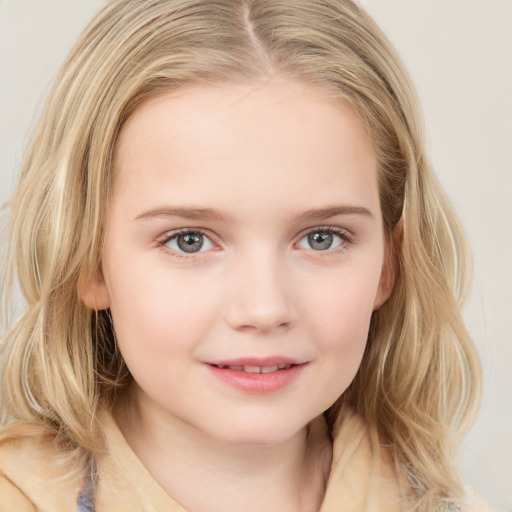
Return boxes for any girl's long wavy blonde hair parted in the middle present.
[2,0,480,511]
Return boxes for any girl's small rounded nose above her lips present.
[225,250,297,333]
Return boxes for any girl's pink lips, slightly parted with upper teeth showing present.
[205,357,308,394]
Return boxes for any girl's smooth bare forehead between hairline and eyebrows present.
[114,80,378,218]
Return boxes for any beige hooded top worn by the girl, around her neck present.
[0,414,486,512]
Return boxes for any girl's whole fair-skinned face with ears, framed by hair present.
[83,80,389,444]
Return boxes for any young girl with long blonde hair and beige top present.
[0,0,483,512]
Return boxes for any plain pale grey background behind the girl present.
[0,0,512,512]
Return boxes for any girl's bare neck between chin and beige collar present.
[114,386,331,512]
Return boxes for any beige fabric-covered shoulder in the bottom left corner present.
[0,425,79,512]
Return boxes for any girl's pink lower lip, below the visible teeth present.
[206,364,306,395]
